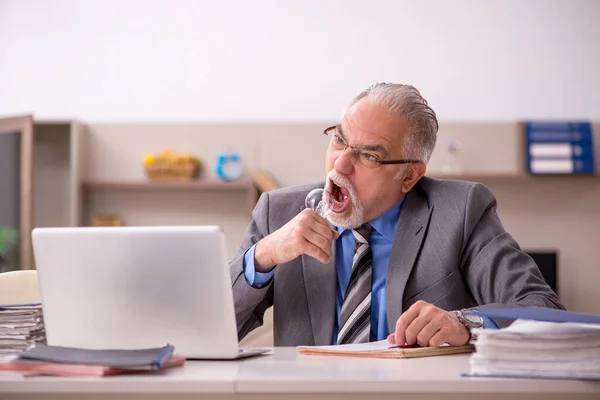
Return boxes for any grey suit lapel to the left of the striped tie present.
[302,247,336,345]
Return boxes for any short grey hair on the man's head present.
[350,82,439,164]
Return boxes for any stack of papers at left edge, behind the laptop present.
[0,304,46,356]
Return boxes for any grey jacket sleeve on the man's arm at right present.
[460,184,564,309]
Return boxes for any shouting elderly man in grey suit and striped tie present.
[230,83,564,346]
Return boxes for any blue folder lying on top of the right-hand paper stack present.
[473,307,600,324]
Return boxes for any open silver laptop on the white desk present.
[32,226,270,359]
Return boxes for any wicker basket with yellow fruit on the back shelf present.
[144,150,202,181]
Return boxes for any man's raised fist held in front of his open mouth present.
[254,208,340,272]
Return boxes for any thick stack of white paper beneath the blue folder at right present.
[470,319,600,380]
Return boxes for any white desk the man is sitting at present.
[0,347,600,400]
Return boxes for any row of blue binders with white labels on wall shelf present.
[525,121,596,175]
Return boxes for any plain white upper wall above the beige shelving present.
[0,0,600,122]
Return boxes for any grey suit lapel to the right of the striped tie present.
[385,185,433,332]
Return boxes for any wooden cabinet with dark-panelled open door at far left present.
[0,115,80,270]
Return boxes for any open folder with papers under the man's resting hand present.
[296,339,475,358]
